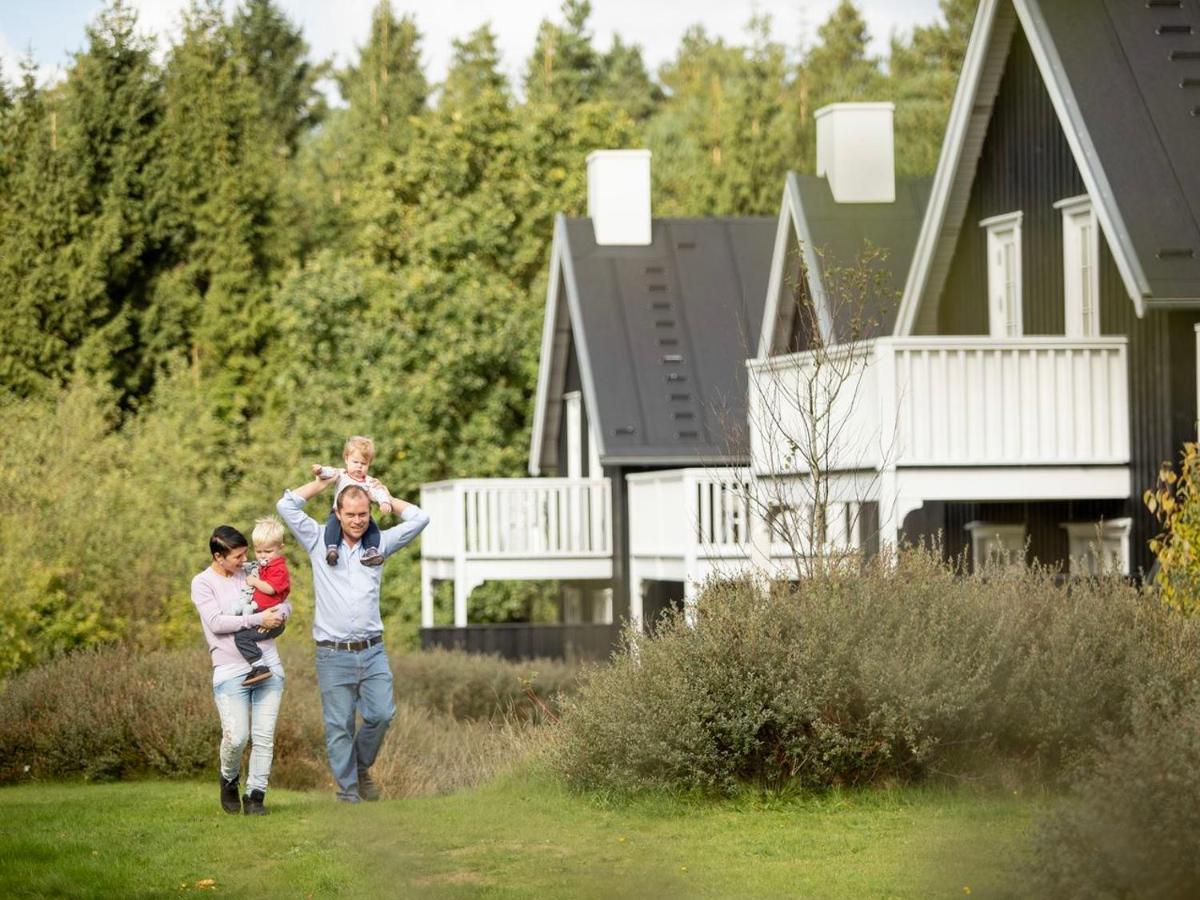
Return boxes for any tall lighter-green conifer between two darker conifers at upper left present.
[145,0,281,424]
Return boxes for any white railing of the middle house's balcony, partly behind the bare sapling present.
[625,468,751,557]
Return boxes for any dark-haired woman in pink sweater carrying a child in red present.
[192,526,292,816]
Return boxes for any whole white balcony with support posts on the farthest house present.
[421,478,612,628]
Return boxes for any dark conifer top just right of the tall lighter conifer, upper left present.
[233,0,328,155]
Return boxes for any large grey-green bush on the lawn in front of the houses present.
[554,551,1200,791]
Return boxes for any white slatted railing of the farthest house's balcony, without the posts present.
[421,478,612,559]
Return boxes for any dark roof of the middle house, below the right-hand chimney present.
[788,173,934,341]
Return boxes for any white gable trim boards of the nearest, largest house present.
[895,0,1151,335]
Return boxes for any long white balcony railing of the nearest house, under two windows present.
[750,336,1129,474]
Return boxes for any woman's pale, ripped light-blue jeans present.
[212,667,283,793]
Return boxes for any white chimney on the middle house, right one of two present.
[816,103,896,203]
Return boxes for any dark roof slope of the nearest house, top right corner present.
[1031,0,1200,300]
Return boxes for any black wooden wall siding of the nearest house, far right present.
[911,26,1200,572]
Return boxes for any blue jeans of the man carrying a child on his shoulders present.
[317,642,396,800]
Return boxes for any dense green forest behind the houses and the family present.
[0,0,974,676]
